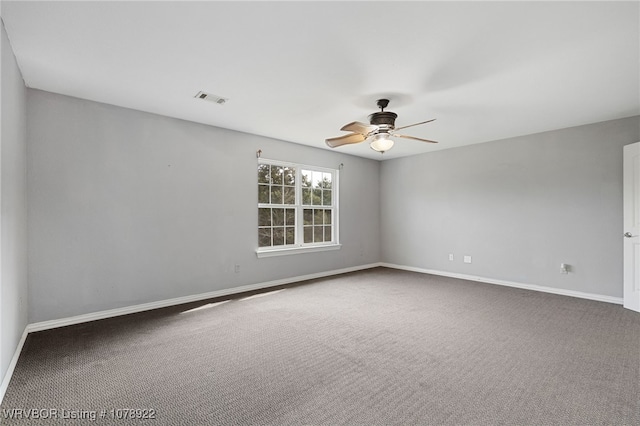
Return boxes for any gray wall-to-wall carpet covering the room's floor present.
[1,268,640,425]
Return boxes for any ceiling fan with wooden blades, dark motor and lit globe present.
[325,99,438,153]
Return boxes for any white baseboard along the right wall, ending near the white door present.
[380,262,622,305]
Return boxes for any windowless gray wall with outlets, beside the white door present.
[380,117,640,297]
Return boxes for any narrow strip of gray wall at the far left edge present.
[0,20,28,377]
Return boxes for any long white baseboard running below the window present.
[27,263,380,333]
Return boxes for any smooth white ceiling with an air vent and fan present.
[1,1,640,160]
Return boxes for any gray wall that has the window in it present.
[27,90,380,322]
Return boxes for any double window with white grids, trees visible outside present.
[258,160,339,256]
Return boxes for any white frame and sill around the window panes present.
[255,158,342,258]
